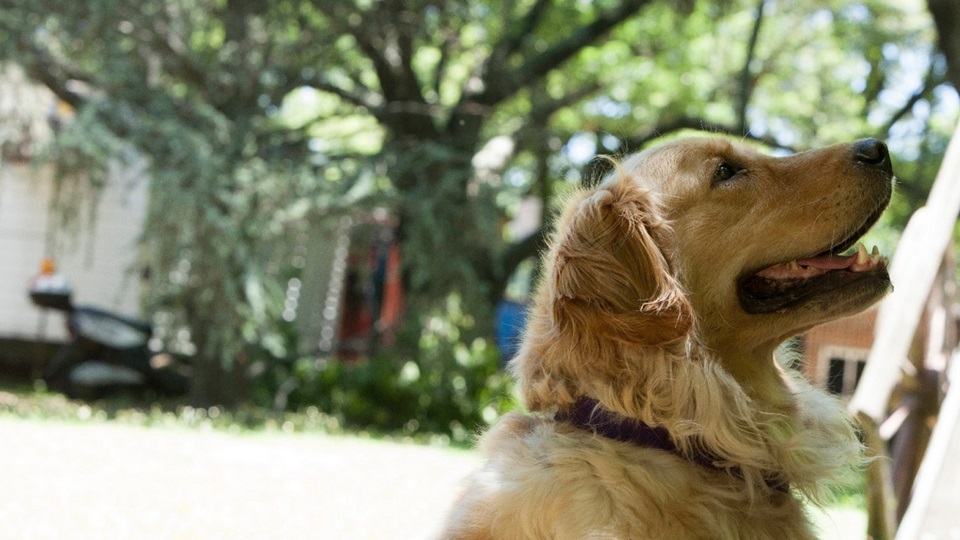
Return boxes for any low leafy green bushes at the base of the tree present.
[266,297,512,443]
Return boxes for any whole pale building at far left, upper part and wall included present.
[0,62,147,364]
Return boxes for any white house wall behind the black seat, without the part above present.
[0,158,147,341]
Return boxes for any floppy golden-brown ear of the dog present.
[548,172,692,346]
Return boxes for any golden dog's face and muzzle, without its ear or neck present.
[624,139,893,350]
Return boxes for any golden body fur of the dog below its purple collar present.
[446,414,815,540]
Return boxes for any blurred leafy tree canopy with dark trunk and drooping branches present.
[0,0,939,410]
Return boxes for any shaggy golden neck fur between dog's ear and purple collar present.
[514,334,859,498]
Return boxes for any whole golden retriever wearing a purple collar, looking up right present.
[441,134,893,540]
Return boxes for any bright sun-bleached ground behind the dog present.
[0,417,864,540]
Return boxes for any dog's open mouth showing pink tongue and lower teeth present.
[738,212,890,315]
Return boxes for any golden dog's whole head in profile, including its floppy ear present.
[516,138,893,408]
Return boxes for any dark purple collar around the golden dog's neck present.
[554,397,789,492]
